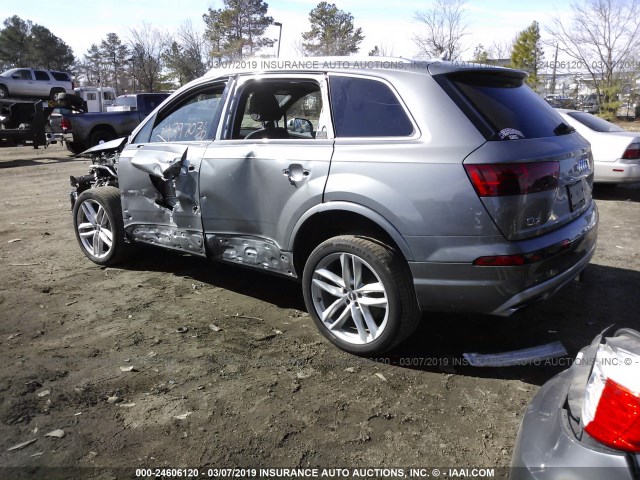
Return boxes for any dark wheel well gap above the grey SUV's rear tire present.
[293,210,401,278]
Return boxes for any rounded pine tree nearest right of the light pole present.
[302,2,364,56]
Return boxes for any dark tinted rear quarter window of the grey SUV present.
[329,76,413,137]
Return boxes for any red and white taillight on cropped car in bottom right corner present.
[582,344,640,453]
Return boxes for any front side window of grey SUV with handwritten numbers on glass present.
[143,84,225,143]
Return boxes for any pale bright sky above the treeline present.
[0,0,570,60]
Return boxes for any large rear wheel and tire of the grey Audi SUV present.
[302,235,420,356]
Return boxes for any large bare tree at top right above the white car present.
[547,0,640,111]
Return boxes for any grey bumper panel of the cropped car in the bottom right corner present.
[510,368,634,480]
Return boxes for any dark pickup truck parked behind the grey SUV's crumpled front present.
[60,93,169,153]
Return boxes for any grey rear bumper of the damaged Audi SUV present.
[409,202,598,316]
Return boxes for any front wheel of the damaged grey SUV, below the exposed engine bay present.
[73,187,130,265]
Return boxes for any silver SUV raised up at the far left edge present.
[0,68,73,99]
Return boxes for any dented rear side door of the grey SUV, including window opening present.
[200,74,333,275]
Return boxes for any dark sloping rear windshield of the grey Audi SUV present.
[449,72,562,140]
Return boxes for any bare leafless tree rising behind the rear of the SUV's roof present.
[413,0,467,60]
